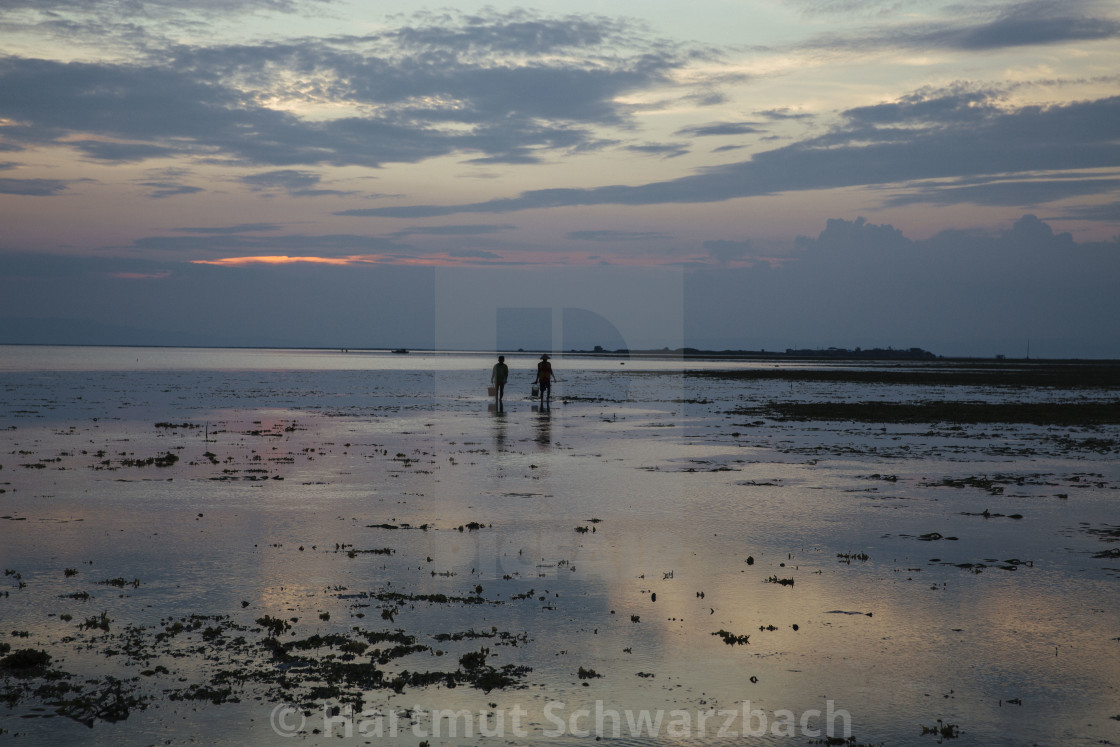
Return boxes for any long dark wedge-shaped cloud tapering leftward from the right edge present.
[338,86,1120,217]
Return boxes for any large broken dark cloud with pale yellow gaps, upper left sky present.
[0,11,696,169]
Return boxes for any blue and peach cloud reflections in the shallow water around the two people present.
[0,356,1120,744]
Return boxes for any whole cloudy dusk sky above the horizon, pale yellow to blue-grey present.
[0,0,1120,358]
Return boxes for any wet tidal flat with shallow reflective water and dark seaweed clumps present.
[0,347,1120,745]
